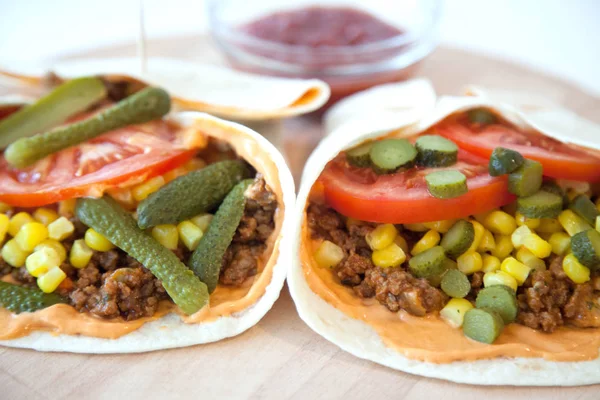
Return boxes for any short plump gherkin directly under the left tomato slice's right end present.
[137,160,250,229]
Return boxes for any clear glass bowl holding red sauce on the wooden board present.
[208,0,440,103]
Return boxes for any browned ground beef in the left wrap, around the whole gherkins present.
[0,179,277,321]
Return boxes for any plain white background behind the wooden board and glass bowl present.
[0,0,600,95]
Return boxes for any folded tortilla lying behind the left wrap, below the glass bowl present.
[0,58,330,120]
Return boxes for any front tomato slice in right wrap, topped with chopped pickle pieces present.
[319,151,515,224]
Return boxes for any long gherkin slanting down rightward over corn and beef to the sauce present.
[76,197,208,315]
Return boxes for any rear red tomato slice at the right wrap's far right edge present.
[435,123,600,182]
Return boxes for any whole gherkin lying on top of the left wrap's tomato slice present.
[4,87,171,168]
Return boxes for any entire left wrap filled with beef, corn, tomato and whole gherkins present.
[0,73,294,353]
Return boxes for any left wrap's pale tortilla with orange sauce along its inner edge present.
[0,112,295,353]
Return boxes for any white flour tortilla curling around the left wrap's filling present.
[0,112,295,353]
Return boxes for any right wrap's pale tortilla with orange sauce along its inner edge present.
[288,86,600,386]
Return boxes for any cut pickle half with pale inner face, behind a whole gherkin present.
[0,77,106,150]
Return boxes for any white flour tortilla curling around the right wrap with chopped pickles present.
[288,90,600,386]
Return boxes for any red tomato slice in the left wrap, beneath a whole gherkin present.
[0,120,195,207]
